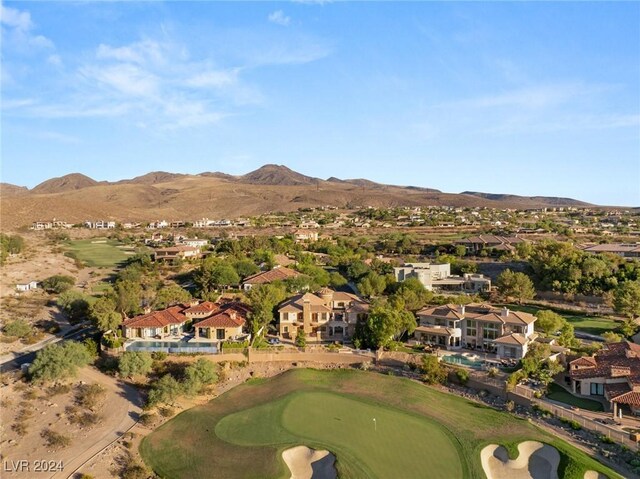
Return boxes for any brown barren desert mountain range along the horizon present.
[0,165,591,228]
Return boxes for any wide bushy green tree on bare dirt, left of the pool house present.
[29,341,93,383]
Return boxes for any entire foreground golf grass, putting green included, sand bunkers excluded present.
[140,369,620,479]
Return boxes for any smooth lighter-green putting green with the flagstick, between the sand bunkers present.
[216,392,464,479]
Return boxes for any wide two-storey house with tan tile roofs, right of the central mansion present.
[414,303,536,359]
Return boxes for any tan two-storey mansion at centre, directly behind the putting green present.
[278,288,369,341]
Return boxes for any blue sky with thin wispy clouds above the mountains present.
[0,1,640,206]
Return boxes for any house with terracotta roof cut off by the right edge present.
[569,341,640,417]
